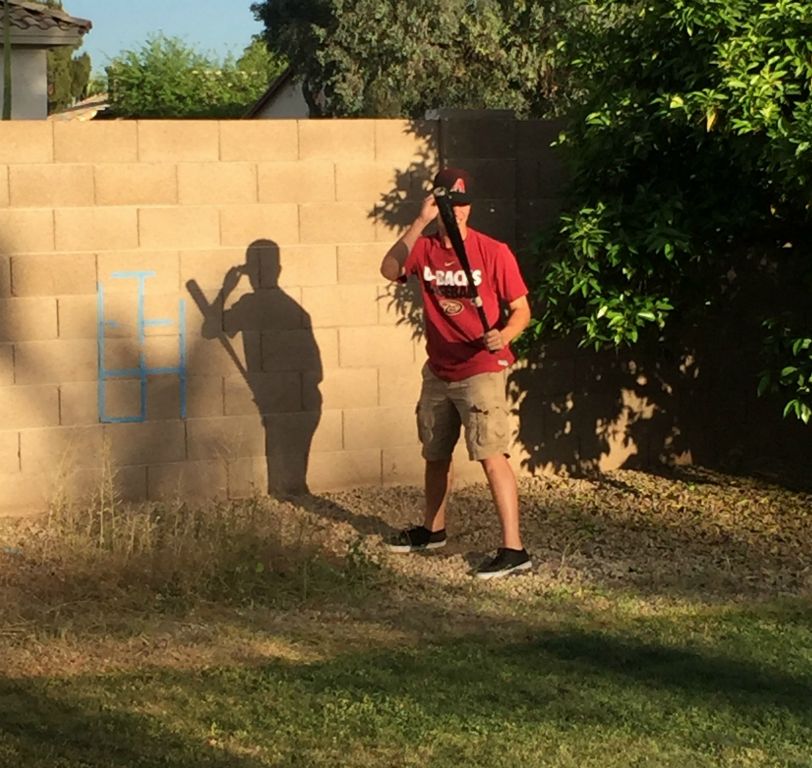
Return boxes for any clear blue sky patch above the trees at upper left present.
[62,0,262,72]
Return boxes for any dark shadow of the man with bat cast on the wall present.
[187,240,323,497]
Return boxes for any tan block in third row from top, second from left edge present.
[54,208,138,251]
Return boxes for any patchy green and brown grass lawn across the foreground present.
[0,473,812,768]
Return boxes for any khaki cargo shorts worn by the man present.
[416,364,509,461]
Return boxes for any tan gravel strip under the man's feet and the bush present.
[306,468,812,595]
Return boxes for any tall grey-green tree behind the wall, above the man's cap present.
[251,0,581,117]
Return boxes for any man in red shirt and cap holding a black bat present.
[381,168,531,579]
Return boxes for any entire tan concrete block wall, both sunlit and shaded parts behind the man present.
[0,114,812,514]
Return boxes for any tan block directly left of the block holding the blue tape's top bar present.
[11,253,96,296]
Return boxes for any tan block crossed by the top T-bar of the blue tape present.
[98,250,180,292]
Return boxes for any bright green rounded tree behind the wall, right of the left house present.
[107,35,284,118]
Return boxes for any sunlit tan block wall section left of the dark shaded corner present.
[0,120,540,511]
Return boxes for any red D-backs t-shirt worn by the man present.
[403,227,527,381]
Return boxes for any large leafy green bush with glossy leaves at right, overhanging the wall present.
[534,0,812,422]
